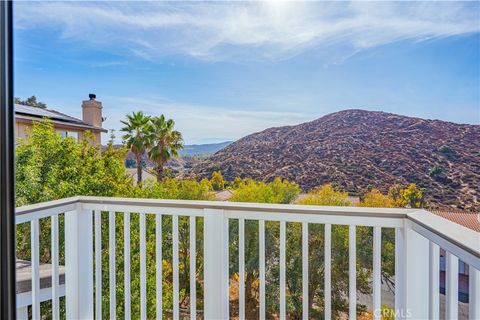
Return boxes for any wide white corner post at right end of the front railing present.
[395,220,429,319]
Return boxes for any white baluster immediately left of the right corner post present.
[373,227,382,319]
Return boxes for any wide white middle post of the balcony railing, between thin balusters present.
[203,209,229,319]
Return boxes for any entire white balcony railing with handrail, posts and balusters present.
[13,197,480,319]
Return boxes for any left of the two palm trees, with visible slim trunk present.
[121,111,151,186]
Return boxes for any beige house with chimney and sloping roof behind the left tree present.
[15,94,107,144]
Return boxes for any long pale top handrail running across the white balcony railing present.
[16,196,480,262]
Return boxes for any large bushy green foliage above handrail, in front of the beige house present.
[16,120,132,206]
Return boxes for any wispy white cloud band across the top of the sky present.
[15,1,480,61]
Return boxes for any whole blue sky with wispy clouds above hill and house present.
[14,1,480,143]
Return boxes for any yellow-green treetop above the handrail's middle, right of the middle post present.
[230,178,300,203]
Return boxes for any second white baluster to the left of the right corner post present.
[348,225,357,320]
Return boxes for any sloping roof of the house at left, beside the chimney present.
[15,104,107,132]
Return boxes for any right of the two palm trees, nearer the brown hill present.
[148,114,183,181]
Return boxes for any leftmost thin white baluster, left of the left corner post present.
[30,219,40,319]
